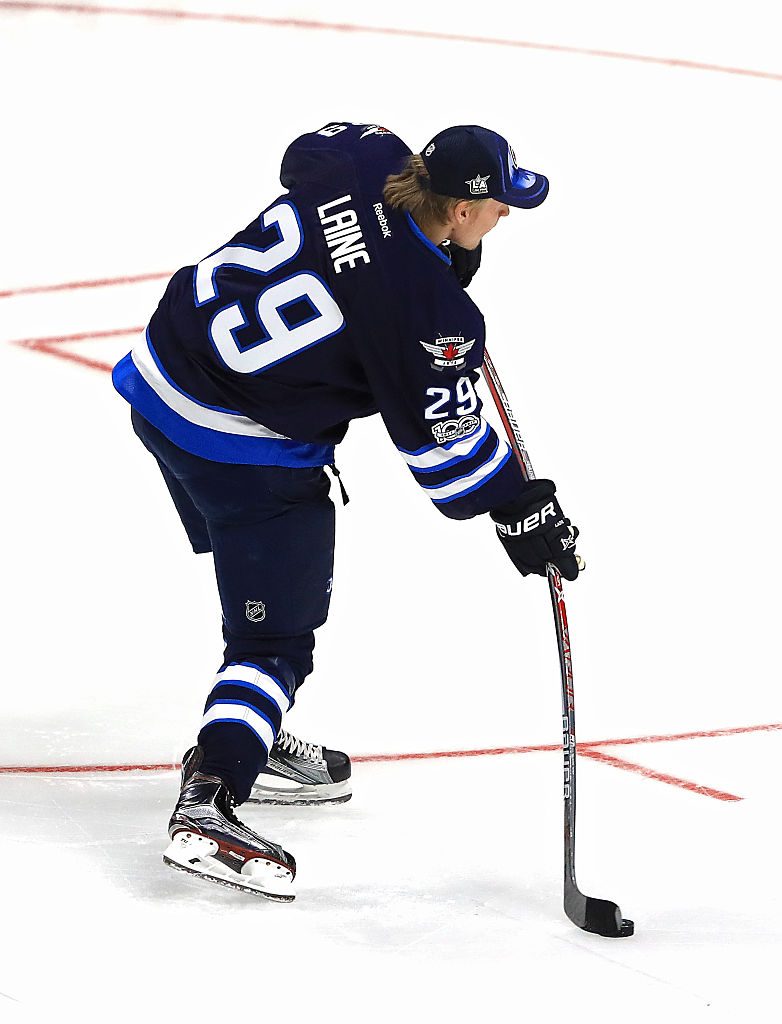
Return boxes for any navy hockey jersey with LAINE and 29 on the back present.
[114,122,522,518]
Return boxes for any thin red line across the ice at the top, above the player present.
[0,0,782,82]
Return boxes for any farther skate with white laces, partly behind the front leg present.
[248,729,352,805]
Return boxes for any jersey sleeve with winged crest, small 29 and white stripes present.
[352,280,523,519]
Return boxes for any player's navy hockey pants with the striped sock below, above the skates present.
[132,410,335,803]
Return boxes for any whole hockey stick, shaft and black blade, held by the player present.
[483,351,635,938]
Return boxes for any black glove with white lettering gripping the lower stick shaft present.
[489,480,578,580]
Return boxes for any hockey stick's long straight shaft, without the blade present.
[483,351,576,902]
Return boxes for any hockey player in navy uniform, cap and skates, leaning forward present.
[114,122,578,900]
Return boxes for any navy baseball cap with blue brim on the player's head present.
[421,125,549,210]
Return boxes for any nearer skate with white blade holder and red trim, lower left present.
[163,765,296,902]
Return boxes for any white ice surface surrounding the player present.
[0,0,782,1024]
